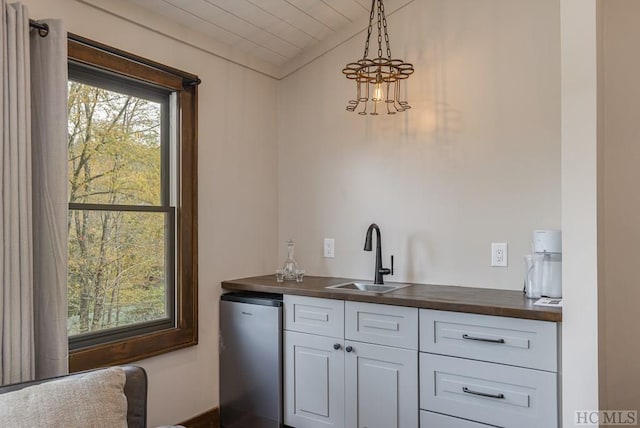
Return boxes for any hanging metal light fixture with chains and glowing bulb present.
[342,0,414,116]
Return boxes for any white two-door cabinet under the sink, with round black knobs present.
[284,295,419,428]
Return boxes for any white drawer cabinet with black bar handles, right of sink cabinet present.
[420,309,559,428]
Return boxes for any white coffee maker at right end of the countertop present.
[532,230,562,298]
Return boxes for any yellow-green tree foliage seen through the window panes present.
[68,82,169,335]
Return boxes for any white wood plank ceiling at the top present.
[122,0,378,66]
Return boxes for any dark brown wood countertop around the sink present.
[222,275,562,322]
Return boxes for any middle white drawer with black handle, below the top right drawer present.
[420,353,558,428]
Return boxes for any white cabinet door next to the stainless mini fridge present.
[284,331,344,428]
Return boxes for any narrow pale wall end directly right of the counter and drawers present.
[561,0,598,427]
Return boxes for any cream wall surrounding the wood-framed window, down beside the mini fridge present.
[24,0,277,426]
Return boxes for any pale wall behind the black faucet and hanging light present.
[278,0,560,289]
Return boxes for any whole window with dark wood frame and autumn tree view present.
[68,35,199,371]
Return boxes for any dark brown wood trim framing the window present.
[68,35,199,372]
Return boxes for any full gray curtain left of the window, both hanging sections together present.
[0,0,68,384]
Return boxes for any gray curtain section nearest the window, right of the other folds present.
[31,15,69,378]
